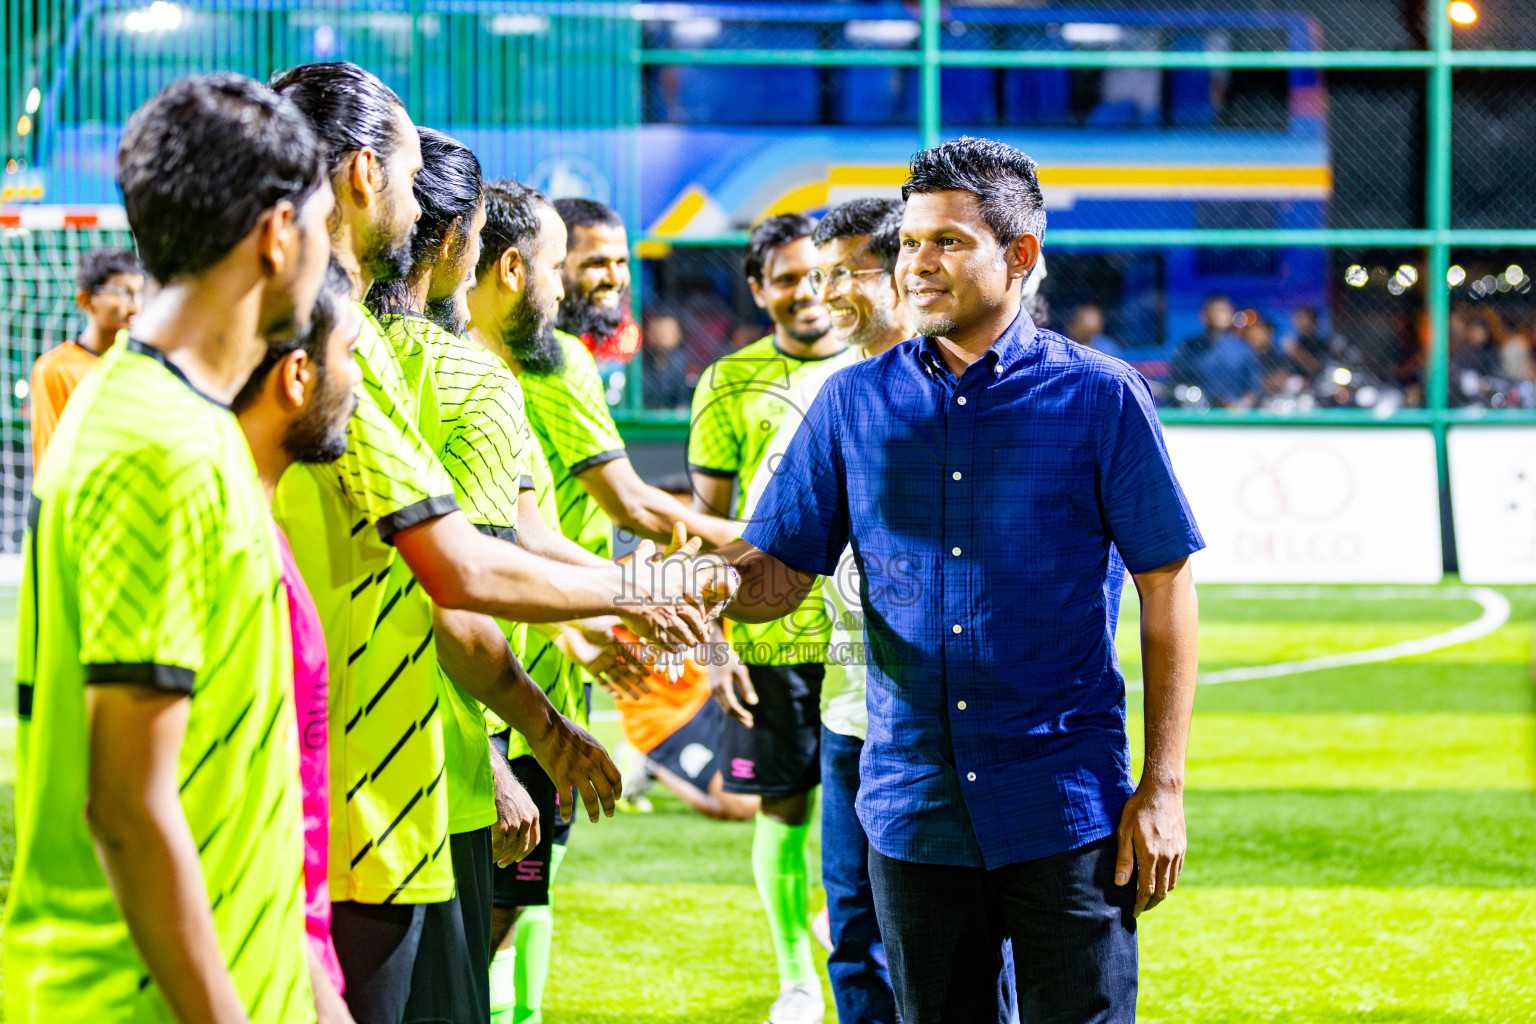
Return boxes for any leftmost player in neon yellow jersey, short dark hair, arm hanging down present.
[5,75,332,1024]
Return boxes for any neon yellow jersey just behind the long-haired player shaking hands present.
[379,315,533,832]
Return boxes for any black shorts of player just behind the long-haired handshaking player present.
[402,826,495,1024]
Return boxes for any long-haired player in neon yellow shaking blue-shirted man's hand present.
[275,63,724,1021]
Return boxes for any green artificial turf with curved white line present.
[0,585,1536,1024]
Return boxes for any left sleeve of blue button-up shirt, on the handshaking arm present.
[742,382,849,576]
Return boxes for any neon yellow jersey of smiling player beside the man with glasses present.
[688,335,842,665]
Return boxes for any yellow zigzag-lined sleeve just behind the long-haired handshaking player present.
[442,375,533,530]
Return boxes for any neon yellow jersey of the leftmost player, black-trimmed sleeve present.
[3,341,315,1024]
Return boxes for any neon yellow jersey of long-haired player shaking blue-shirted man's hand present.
[273,313,458,903]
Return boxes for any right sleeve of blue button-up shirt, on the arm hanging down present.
[1098,373,1206,573]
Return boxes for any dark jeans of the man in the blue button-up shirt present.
[869,837,1137,1024]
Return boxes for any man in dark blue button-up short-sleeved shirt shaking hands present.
[720,138,1204,1024]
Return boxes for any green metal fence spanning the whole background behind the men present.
[0,0,1536,509]
